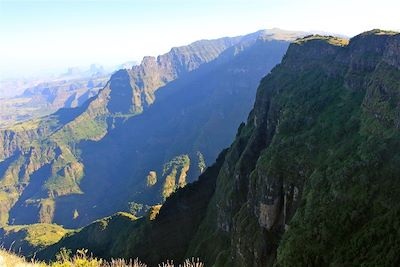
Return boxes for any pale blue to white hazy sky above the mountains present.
[0,0,400,78]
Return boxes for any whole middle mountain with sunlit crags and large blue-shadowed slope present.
[0,32,293,228]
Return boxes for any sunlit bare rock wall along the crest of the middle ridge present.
[109,37,242,113]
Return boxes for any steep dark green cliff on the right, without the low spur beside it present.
[189,30,400,266]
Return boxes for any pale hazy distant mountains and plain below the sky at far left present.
[0,61,137,128]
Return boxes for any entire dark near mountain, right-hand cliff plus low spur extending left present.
[36,30,400,266]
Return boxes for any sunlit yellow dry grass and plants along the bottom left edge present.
[0,249,204,267]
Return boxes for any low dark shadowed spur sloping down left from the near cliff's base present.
[36,153,228,266]
